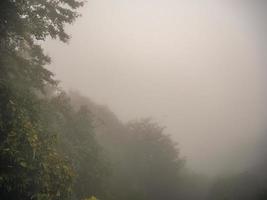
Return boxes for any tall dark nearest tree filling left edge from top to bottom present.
[0,0,83,200]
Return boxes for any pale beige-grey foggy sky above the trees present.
[45,0,267,174]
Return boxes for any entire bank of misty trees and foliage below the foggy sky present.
[0,0,267,200]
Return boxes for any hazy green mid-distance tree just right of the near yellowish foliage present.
[47,93,109,199]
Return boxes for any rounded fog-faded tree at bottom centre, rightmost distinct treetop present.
[107,119,184,200]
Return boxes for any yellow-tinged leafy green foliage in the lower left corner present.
[0,86,73,199]
